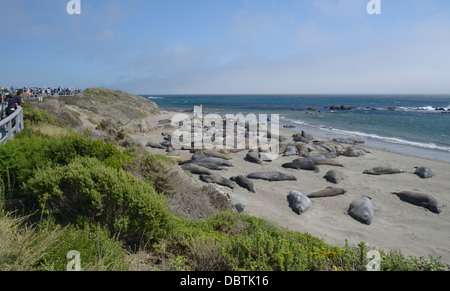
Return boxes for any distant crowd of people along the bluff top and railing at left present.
[0,86,81,118]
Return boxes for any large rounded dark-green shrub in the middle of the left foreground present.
[24,157,170,243]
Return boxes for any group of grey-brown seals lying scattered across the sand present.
[163,131,443,225]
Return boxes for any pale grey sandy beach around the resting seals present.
[131,111,450,263]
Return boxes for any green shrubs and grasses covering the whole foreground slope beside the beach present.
[0,104,448,271]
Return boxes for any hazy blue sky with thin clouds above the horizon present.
[0,0,450,94]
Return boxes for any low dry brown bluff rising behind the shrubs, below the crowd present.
[32,87,165,134]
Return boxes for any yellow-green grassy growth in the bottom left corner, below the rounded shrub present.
[0,212,129,271]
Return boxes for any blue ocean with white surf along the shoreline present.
[141,95,450,162]
